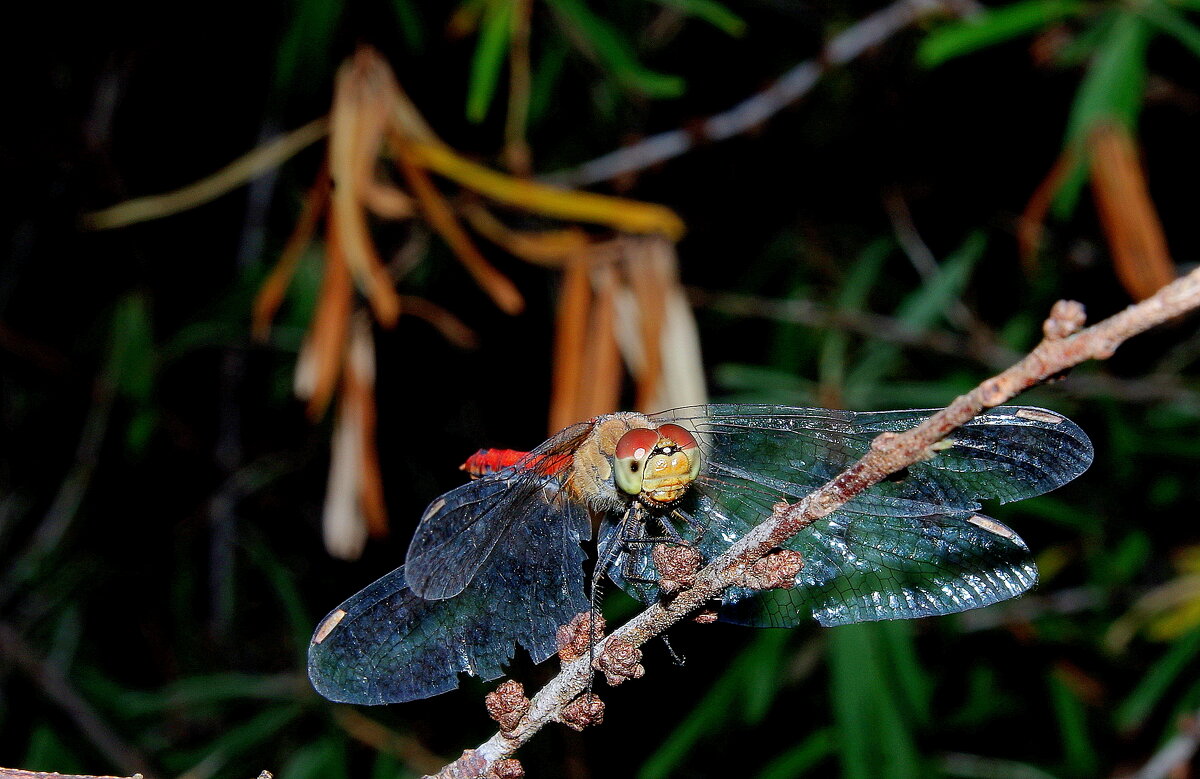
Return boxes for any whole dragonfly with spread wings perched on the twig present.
[308,405,1093,705]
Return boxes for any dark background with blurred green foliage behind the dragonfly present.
[7,0,1200,779]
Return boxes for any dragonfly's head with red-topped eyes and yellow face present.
[612,425,701,505]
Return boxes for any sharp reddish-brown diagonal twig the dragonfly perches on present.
[438,269,1200,777]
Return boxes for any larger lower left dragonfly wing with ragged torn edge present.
[308,480,589,703]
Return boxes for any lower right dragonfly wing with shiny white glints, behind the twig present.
[601,484,1037,628]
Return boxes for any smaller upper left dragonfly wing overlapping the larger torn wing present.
[404,423,592,600]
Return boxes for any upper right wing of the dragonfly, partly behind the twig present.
[655,405,1092,510]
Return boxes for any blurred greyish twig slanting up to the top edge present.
[542,0,964,187]
